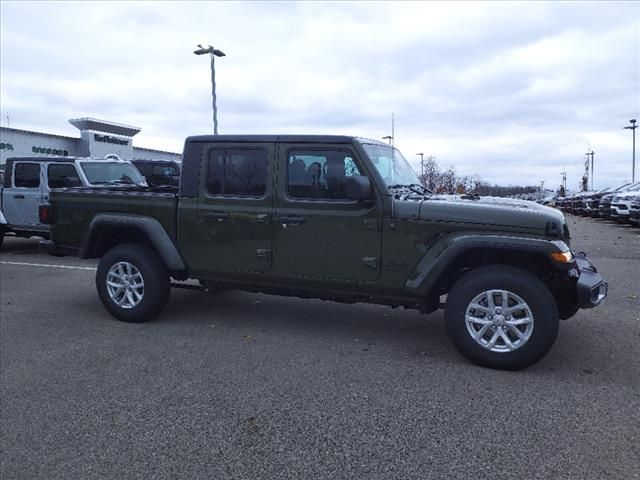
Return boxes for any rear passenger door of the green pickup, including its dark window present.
[185,143,275,278]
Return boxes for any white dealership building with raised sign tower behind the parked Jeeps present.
[0,118,182,169]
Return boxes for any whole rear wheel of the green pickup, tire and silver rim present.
[96,244,171,323]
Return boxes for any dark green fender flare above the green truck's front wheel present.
[405,233,569,297]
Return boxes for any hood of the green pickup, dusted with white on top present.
[394,195,566,238]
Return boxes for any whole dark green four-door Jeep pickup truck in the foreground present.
[40,135,607,369]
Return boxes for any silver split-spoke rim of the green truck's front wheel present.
[465,290,534,353]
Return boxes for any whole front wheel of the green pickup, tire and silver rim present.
[445,265,559,370]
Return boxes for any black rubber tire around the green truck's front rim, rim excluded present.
[445,265,559,370]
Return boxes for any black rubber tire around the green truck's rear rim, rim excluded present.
[96,243,171,323]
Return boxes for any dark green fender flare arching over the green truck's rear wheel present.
[80,213,187,272]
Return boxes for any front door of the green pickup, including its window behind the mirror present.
[274,144,382,281]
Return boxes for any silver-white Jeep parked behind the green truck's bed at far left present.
[0,157,145,245]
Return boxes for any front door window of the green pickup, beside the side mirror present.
[287,150,362,199]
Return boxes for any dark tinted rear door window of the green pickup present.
[207,149,267,197]
